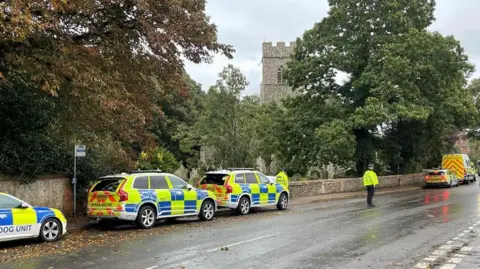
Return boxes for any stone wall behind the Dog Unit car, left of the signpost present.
[0,176,73,214]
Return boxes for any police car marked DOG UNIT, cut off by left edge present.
[0,193,67,242]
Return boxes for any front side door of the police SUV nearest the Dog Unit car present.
[168,175,192,215]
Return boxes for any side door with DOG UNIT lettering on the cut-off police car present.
[0,195,36,240]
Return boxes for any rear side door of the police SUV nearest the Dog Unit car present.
[150,175,172,217]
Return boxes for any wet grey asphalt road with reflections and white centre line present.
[0,182,480,269]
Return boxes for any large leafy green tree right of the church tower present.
[287,0,474,173]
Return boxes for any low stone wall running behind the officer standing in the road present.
[288,173,425,197]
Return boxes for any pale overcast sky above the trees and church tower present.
[186,0,480,94]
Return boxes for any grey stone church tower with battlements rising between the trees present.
[260,42,295,103]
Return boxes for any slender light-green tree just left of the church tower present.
[182,65,248,167]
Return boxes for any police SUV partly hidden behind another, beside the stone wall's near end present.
[198,168,290,215]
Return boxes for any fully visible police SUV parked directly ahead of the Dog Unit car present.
[87,170,217,229]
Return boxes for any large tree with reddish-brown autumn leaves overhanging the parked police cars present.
[0,0,233,180]
